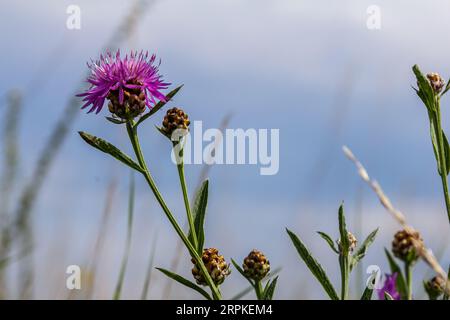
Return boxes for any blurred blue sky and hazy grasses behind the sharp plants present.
[0,0,450,299]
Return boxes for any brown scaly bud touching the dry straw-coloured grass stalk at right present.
[392,230,423,263]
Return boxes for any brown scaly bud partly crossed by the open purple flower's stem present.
[191,248,231,286]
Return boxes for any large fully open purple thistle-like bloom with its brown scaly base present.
[77,50,170,119]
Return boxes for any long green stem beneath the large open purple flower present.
[126,121,222,300]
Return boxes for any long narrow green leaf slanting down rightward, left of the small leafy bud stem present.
[286,229,339,300]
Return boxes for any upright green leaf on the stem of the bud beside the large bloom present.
[189,180,209,255]
